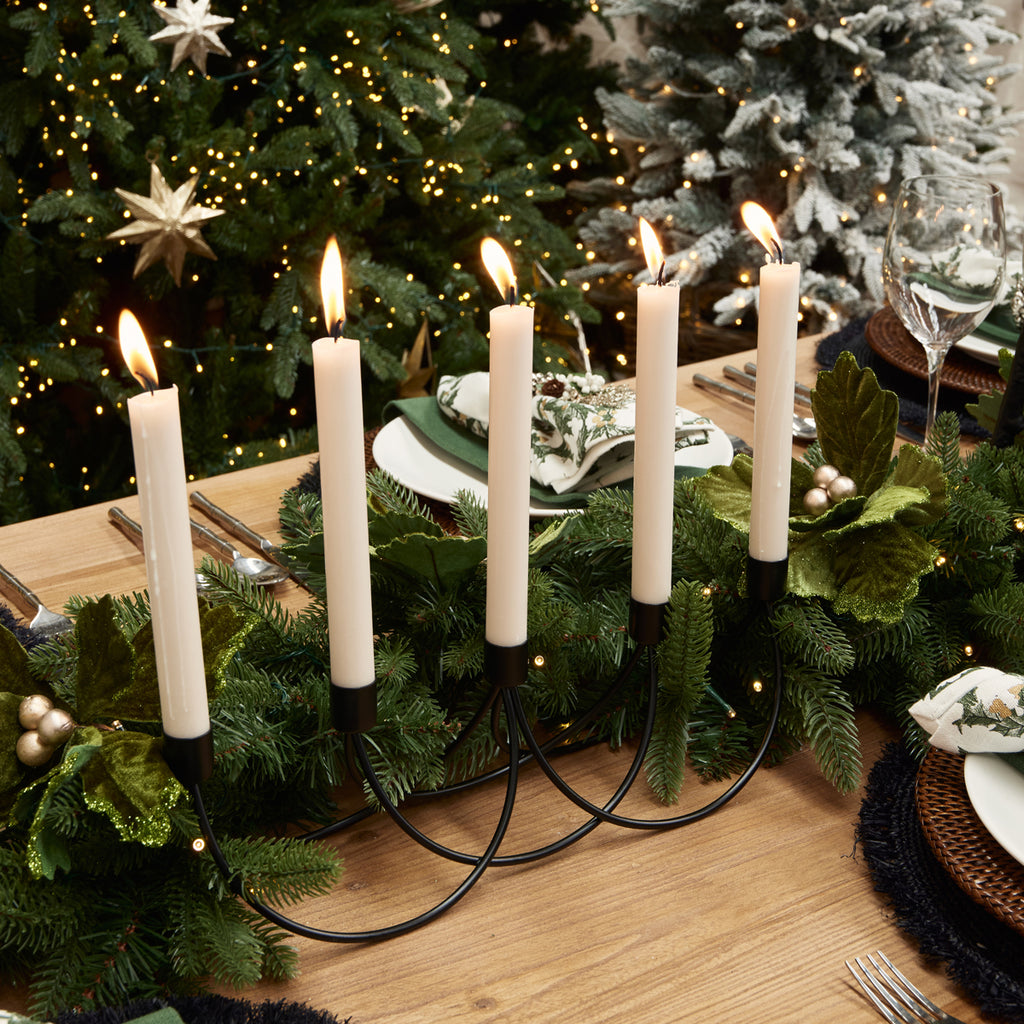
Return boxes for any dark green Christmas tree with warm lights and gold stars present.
[0,0,610,520]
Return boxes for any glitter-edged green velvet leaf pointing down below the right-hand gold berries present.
[833,522,936,623]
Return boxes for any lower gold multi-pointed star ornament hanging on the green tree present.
[106,164,224,285]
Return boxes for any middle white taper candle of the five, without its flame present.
[484,305,534,647]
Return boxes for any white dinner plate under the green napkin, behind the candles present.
[373,416,732,516]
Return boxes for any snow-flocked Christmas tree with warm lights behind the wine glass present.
[582,0,1018,330]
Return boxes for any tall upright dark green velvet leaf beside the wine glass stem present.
[811,352,899,496]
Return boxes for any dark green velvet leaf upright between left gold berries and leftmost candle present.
[75,595,140,722]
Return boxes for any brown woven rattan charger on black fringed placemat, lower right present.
[916,750,1024,934]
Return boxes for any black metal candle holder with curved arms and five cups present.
[182,558,785,943]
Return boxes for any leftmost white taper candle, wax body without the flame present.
[128,387,210,739]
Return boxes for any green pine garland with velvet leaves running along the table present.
[0,356,1024,1015]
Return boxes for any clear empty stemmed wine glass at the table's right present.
[882,174,1006,439]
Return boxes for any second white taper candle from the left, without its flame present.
[312,338,376,688]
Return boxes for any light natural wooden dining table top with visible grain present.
[0,344,981,1024]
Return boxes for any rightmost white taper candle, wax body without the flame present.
[750,263,800,562]
